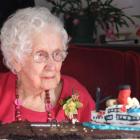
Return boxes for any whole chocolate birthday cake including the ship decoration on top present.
[0,84,140,140]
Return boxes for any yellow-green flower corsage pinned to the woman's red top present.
[60,90,83,120]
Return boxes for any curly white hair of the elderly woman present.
[0,7,68,72]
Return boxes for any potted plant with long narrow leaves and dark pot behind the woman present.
[46,0,134,43]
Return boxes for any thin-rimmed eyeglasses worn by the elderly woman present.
[33,50,68,63]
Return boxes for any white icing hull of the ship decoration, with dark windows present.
[91,104,140,124]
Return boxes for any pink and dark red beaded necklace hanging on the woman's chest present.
[15,90,53,122]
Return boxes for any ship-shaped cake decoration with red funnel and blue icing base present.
[89,85,140,130]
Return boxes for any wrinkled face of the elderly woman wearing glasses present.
[19,28,63,90]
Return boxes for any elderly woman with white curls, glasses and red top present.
[0,7,95,123]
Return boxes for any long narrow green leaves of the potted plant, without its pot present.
[46,0,134,39]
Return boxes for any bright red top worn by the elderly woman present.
[0,72,95,122]
